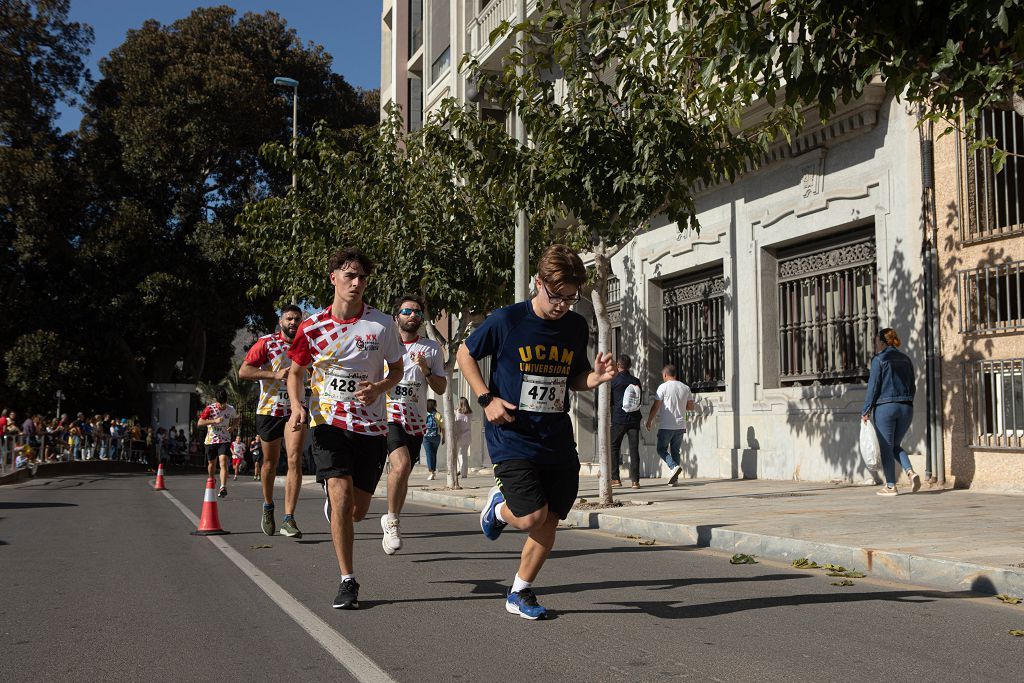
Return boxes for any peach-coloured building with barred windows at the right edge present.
[935,111,1024,492]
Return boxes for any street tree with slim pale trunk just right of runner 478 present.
[466,0,796,503]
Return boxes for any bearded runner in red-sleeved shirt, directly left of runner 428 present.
[239,304,306,539]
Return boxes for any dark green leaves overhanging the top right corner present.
[708,0,1024,129]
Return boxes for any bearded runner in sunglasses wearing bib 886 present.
[381,294,447,555]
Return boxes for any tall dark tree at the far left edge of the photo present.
[0,0,92,408]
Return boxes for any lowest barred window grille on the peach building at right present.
[964,358,1024,450]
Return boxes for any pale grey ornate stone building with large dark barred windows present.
[382,0,966,481]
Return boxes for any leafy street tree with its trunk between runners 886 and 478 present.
[241,101,546,487]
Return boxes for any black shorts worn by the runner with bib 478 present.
[495,458,580,519]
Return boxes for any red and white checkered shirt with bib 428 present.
[288,304,404,434]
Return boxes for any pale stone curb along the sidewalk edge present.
[409,488,1024,596]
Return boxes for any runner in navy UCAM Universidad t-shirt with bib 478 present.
[457,245,615,620]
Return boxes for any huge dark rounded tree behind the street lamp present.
[71,6,377,411]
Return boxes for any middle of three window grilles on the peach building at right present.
[956,261,1024,332]
